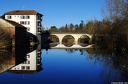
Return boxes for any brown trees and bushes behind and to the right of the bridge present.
[43,0,128,56]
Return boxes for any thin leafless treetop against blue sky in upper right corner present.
[102,0,128,22]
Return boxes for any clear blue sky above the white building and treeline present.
[0,0,105,28]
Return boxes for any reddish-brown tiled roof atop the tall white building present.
[4,10,42,15]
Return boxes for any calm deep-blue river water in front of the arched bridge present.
[0,45,128,84]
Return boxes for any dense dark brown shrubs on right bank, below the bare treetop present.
[90,20,128,52]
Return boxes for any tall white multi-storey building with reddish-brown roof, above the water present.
[4,10,43,42]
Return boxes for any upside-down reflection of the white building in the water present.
[8,46,42,74]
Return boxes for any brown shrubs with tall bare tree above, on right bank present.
[90,0,128,56]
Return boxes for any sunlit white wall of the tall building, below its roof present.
[5,15,41,43]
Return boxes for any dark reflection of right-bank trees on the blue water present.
[86,48,128,84]
